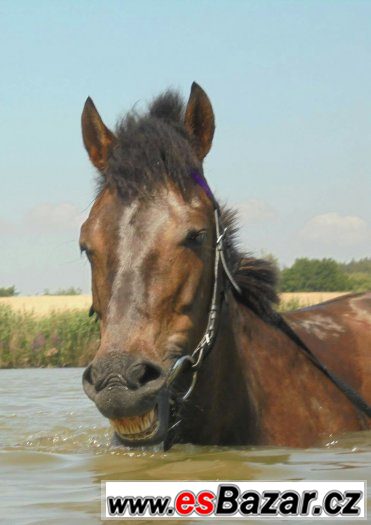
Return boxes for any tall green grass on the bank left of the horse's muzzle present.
[0,304,99,368]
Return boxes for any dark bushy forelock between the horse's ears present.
[99,91,202,202]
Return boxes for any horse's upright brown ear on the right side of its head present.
[184,82,215,161]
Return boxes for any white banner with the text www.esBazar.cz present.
[102,481,366,521]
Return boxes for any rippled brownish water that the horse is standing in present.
[0,369,371,525]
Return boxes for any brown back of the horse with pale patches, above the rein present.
[284,292,371,403]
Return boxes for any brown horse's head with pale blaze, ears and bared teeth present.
[80,83,216,446]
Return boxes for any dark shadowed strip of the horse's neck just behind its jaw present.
[183,295,257,445]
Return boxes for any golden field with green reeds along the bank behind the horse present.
[0,292,352,368]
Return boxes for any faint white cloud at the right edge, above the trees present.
[300,212,370,246]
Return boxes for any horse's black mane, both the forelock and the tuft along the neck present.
[99,91,278,322]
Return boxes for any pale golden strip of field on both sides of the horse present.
[0,292,348,316]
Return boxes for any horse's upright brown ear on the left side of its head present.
[81,97,116,171]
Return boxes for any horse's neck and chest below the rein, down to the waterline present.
[199,293,368,446]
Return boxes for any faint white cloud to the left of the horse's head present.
[23,202,83,232]
